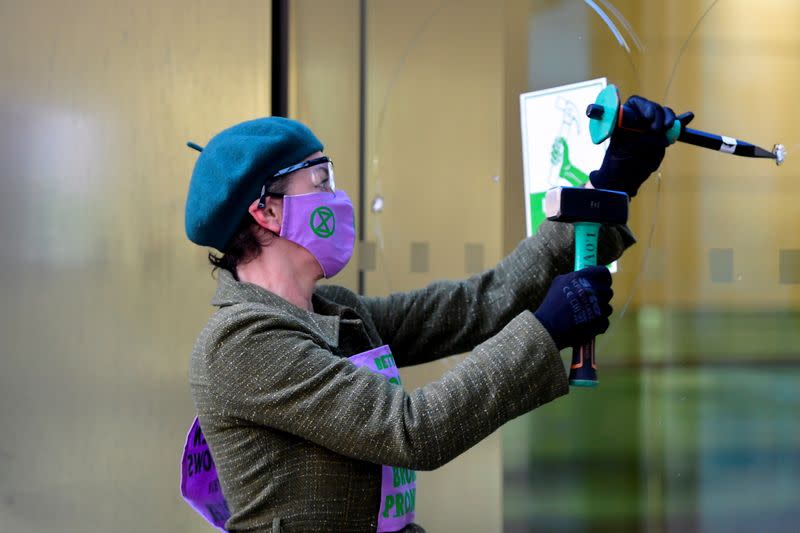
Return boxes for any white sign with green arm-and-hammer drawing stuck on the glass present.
[520,78,608,236]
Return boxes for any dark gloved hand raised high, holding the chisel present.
[589,96,693,197]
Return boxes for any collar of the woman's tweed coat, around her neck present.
[211,269,346,347]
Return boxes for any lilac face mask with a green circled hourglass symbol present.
[281,191,356,278]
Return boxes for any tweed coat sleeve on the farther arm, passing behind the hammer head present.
[361,221,635,367]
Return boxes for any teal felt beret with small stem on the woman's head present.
[185,117,322,252]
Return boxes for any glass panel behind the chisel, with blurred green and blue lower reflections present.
[503,0,800,532]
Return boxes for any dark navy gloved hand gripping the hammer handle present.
[533,266,614,350]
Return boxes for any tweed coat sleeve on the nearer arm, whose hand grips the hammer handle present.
[202,306,568,470]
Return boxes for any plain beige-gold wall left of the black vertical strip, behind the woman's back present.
[0,0,270,533]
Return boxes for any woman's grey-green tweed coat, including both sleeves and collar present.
[190,218,634,532]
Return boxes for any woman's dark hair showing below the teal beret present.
[208,175,289,280]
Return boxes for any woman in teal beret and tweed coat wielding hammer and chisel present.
[184,99,674,532]
